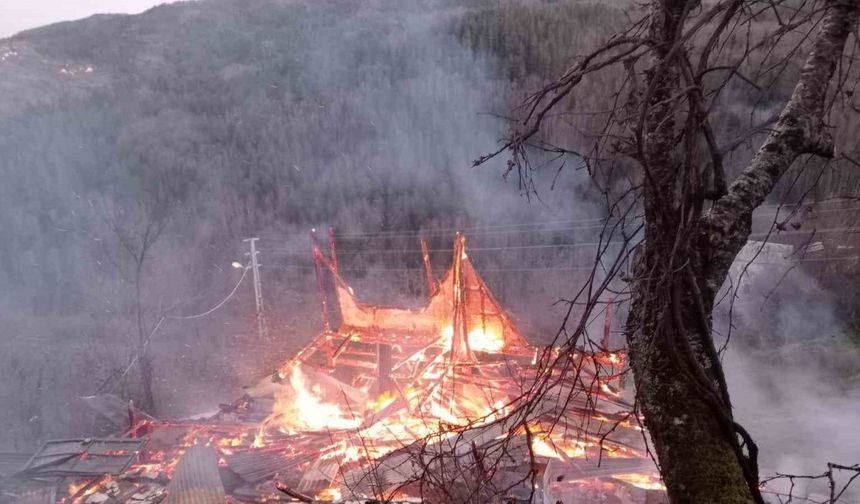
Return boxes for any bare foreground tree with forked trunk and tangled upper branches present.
[475,0,860,498]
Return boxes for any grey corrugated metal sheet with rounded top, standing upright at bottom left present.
[164,444,225,504]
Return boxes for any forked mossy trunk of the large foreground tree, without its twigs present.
[626,0,860,504]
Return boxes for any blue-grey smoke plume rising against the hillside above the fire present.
[282,1,595,226]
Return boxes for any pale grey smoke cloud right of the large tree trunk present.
[715,242,860,498]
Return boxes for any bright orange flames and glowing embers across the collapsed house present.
[60,236,664,502]
